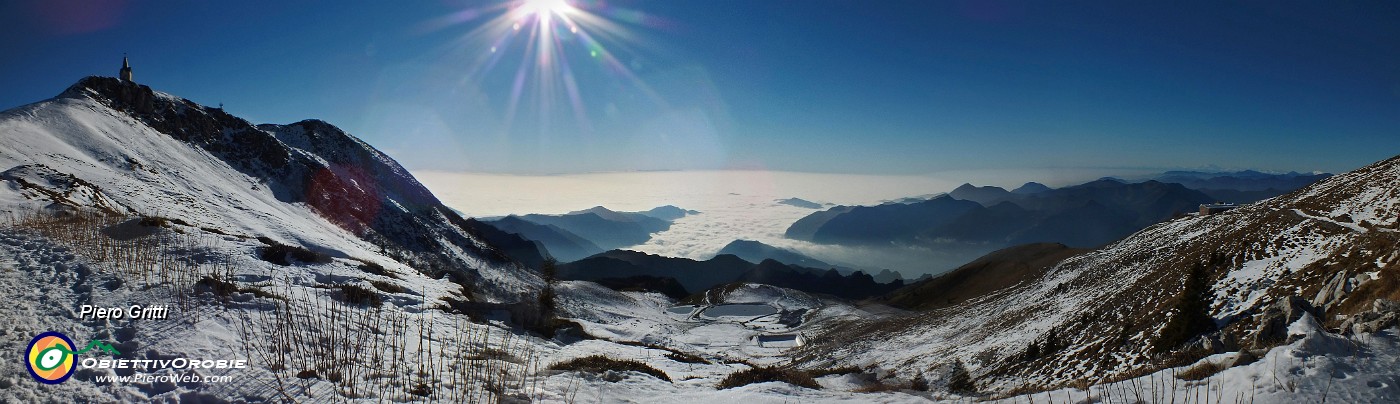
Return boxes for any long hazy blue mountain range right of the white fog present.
[785,171,1329,247]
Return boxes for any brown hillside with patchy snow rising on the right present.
[799,157,1400,391]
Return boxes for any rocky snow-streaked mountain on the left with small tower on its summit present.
[0,77,540,301]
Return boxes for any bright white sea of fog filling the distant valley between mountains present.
[413,169,1148,277]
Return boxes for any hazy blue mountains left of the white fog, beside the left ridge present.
[484,205,699,261]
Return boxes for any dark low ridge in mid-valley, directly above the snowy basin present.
[559,250,904,299]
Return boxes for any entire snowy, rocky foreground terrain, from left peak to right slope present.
[0,77,1400,403]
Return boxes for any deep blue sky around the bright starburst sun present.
[0,0,1400,173]
